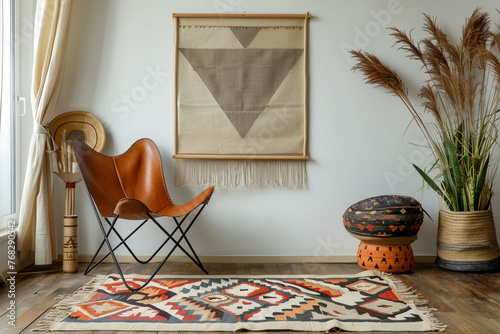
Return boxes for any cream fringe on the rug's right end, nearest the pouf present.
[374,271,447,332]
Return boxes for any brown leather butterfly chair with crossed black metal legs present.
[73,138,214,291]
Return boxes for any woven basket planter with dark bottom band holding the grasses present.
[436,209,500,272]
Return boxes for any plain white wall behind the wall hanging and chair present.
[20,0,500,257]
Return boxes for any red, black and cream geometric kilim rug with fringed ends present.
[36,271,445,332]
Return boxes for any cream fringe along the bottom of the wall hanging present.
[175,159,307,188]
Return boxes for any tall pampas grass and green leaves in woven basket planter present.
[351,9,500,271]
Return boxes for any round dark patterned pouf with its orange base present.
[343,195,424,273]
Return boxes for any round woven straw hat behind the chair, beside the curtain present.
[49,111,106,152]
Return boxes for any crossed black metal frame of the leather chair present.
[84,181,208,292]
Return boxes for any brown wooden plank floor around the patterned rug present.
[0,263,500,334]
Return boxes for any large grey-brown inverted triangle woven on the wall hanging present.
[179,48,304,138]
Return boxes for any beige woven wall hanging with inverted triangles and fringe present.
[174,14,309,187]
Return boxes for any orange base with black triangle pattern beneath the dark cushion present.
[357,241,415,273]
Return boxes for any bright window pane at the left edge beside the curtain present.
[0,0,17,224]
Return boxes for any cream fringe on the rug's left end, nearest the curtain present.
[31,275,109,332]
